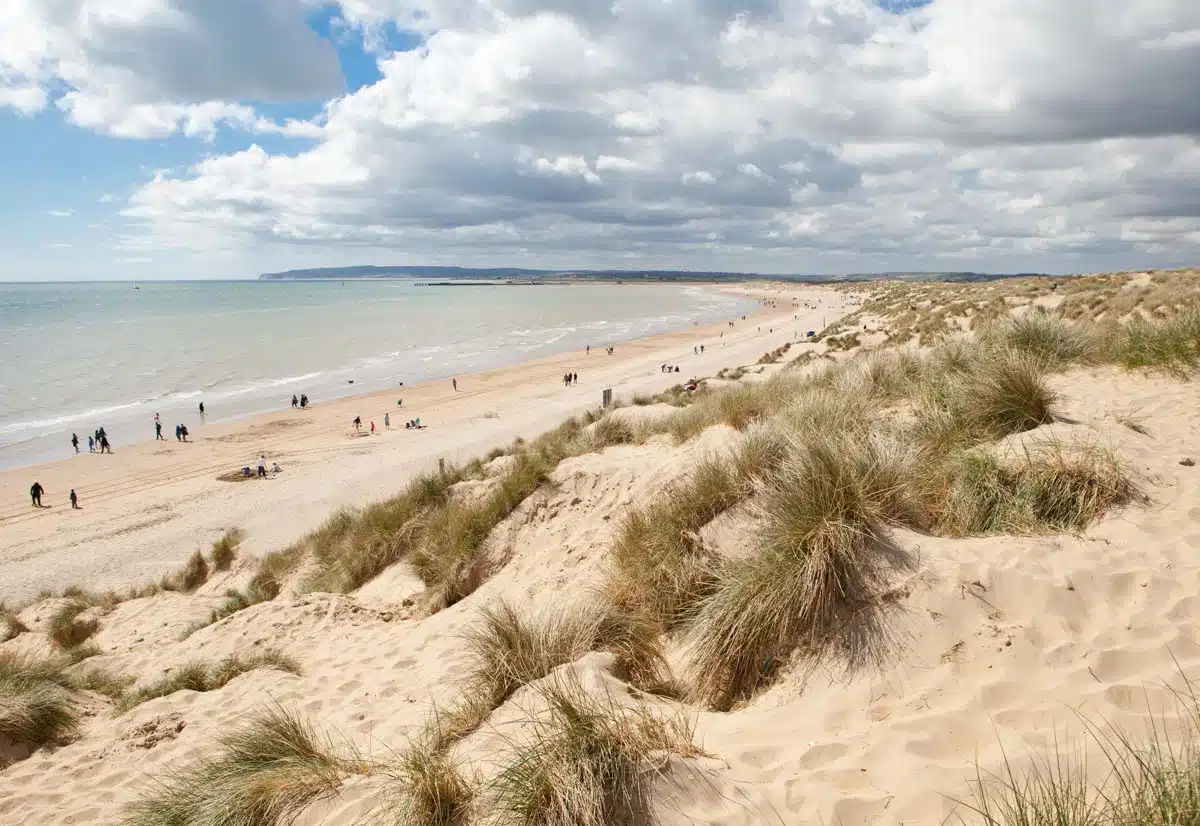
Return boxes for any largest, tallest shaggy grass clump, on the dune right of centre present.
[688,433,925,710]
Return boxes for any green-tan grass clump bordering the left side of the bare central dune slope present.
[409,443,549,610]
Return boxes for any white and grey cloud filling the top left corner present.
[0,0,342,138]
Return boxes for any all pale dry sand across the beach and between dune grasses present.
[0,278,1200,826]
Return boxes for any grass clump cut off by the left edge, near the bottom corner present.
[0,654,79,747]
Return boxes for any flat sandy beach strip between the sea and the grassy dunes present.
[0,282,854,600]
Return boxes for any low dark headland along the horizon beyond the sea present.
[258,265,1044,287]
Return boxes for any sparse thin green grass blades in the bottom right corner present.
[958,684,1200,826]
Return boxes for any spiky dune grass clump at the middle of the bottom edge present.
[487,680,701,826]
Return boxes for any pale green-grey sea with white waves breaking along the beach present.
[0,280,754,467]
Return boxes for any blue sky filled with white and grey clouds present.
[0,0,1200,281]
